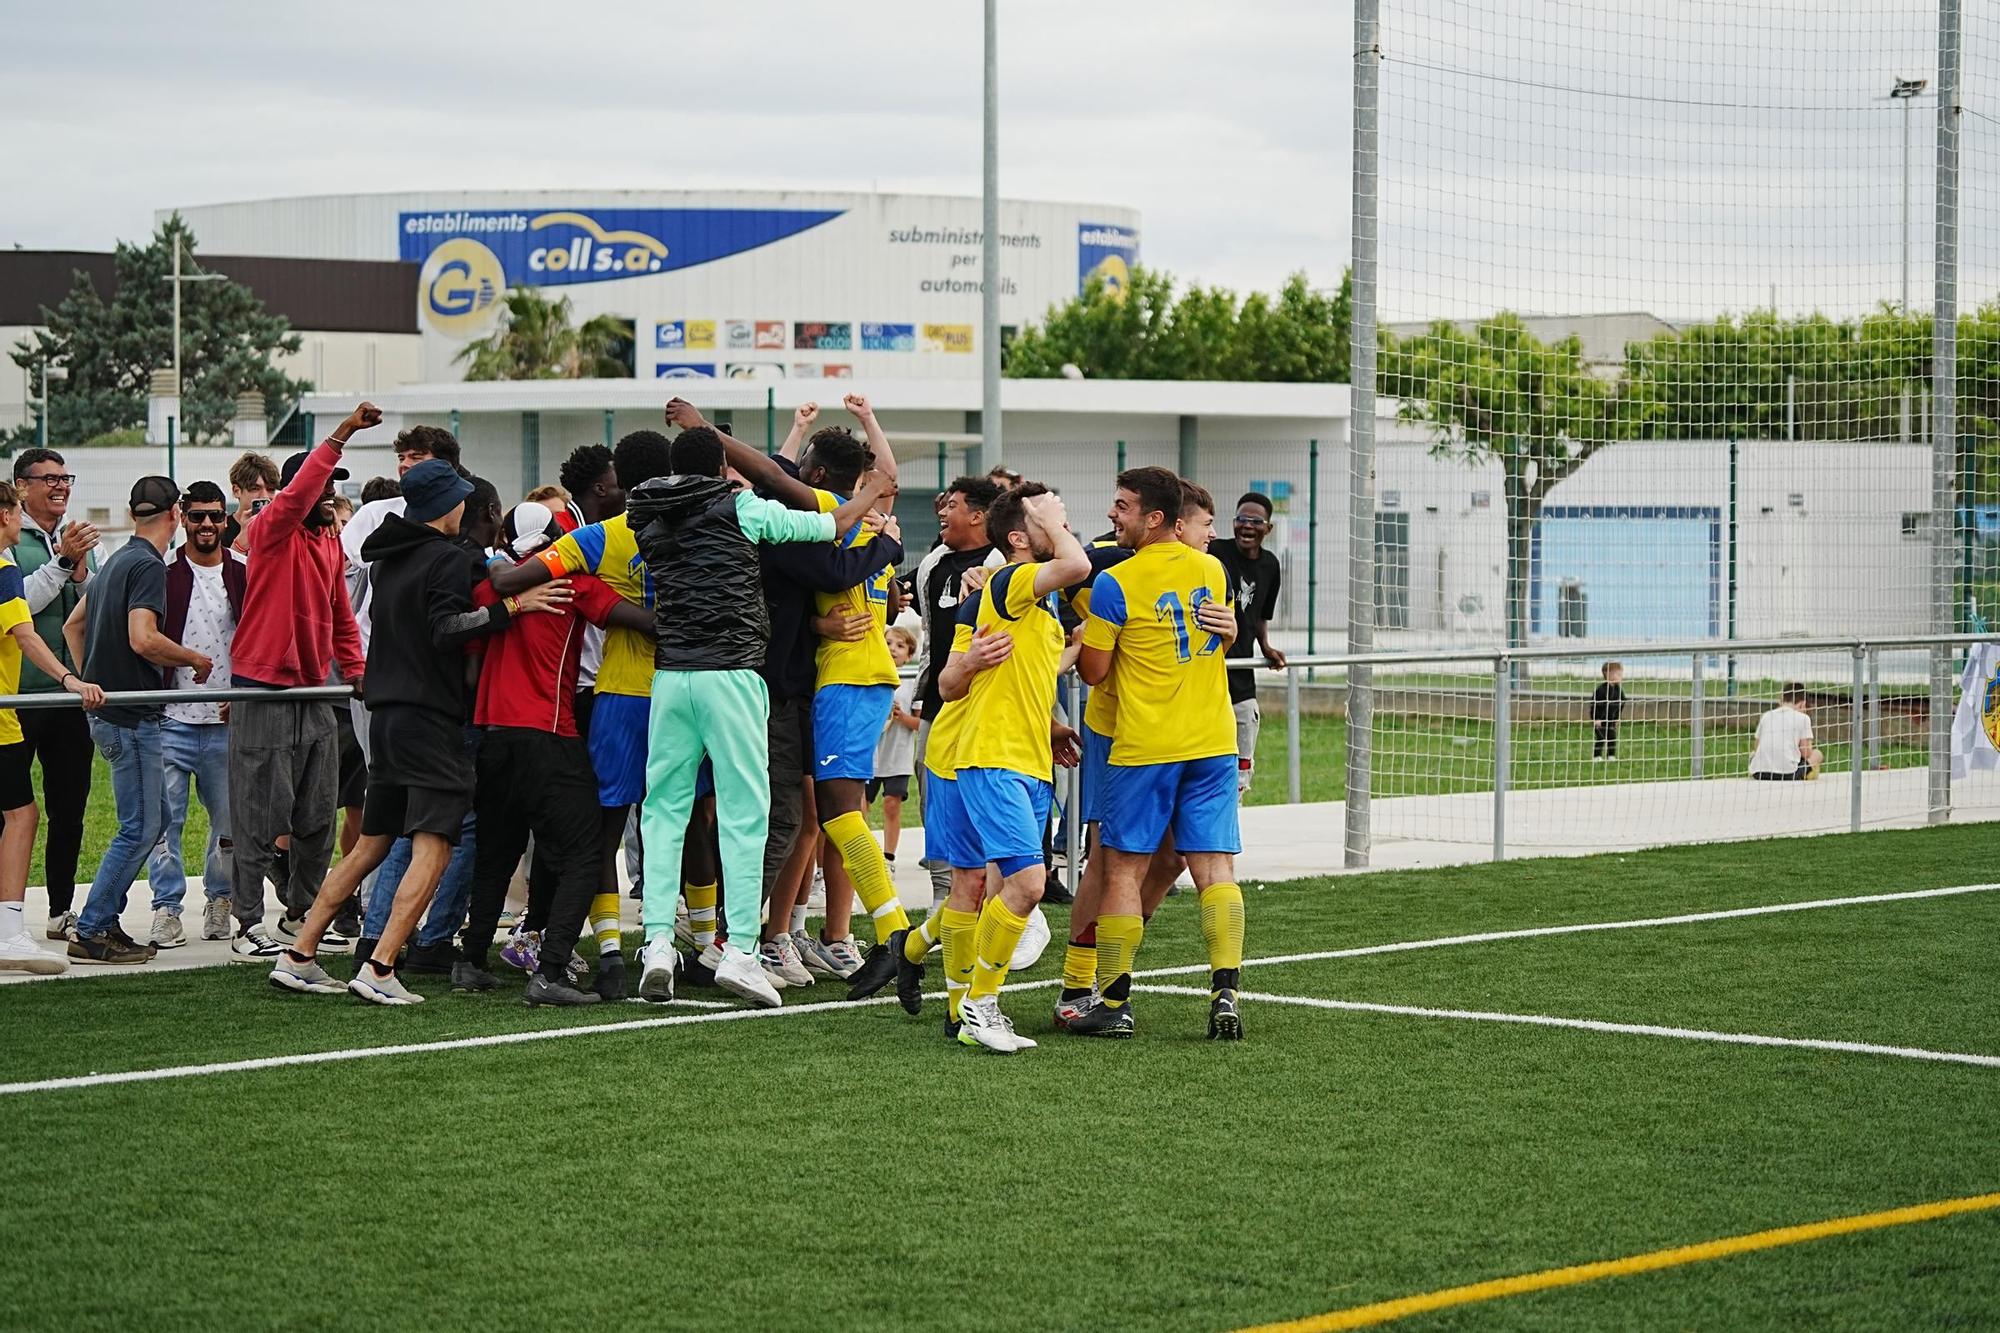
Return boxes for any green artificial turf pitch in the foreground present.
[0,827,2000,1331]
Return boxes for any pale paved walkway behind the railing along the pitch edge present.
[0,769,2000,983]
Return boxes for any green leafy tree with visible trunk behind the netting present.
[1376,312,1644,646]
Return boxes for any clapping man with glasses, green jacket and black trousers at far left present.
[14,448,100,939]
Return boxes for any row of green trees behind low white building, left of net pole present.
[1006,266,1354,384]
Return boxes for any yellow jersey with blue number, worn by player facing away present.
[1084,542,1236,767]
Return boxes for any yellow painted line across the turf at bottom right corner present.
[1238,1195,2000,1333]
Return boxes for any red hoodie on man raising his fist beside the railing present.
[230,440,366,687]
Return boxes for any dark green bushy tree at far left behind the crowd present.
[6,214,312,448]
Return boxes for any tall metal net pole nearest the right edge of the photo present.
[1928,0,1960,825]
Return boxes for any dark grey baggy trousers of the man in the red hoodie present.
[230,697,346,927]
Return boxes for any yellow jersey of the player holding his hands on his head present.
[958,562,1064,783]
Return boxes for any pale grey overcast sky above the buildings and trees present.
[0,0,2000,318]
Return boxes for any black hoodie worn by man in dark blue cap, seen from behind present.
[362,514,508,723]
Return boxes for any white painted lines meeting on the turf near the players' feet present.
[0,885,2000,1097]
